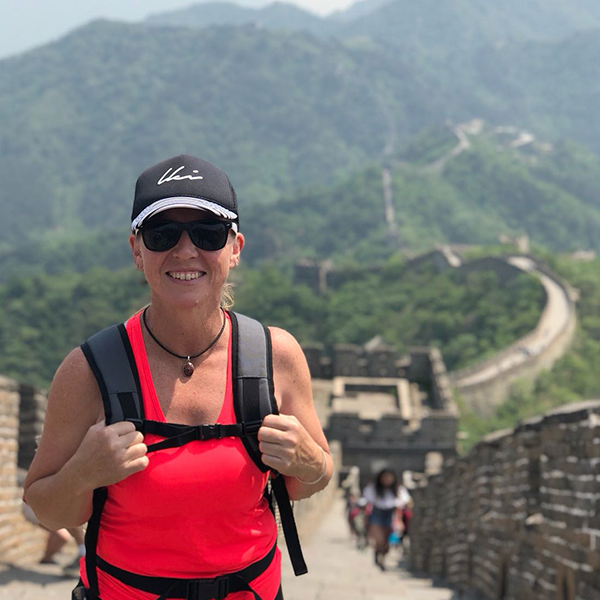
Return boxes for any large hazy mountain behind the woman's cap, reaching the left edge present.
[0,21,461,249]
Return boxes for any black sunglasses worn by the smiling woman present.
[140,220,232,252]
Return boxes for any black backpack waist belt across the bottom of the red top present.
[96,546,276,600]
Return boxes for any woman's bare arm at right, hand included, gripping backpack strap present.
[258,327,333,500]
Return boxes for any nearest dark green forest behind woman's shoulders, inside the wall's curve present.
[0,258,545,386]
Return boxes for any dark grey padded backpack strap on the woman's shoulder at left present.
[81,323,144,425]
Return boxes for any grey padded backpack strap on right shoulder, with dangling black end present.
[229,312,308,575]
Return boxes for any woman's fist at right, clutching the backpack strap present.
[258,414,324,481]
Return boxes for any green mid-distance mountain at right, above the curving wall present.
[244,129,600,263]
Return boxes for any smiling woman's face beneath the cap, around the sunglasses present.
[129,208,244,308]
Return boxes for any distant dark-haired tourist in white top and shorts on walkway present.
[363,469,410,571]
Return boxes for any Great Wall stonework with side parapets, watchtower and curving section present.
[0,249,600,600]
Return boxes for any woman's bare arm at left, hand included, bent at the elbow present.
[24,348,148,529]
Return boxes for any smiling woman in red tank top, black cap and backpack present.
[25,155,333,600]
